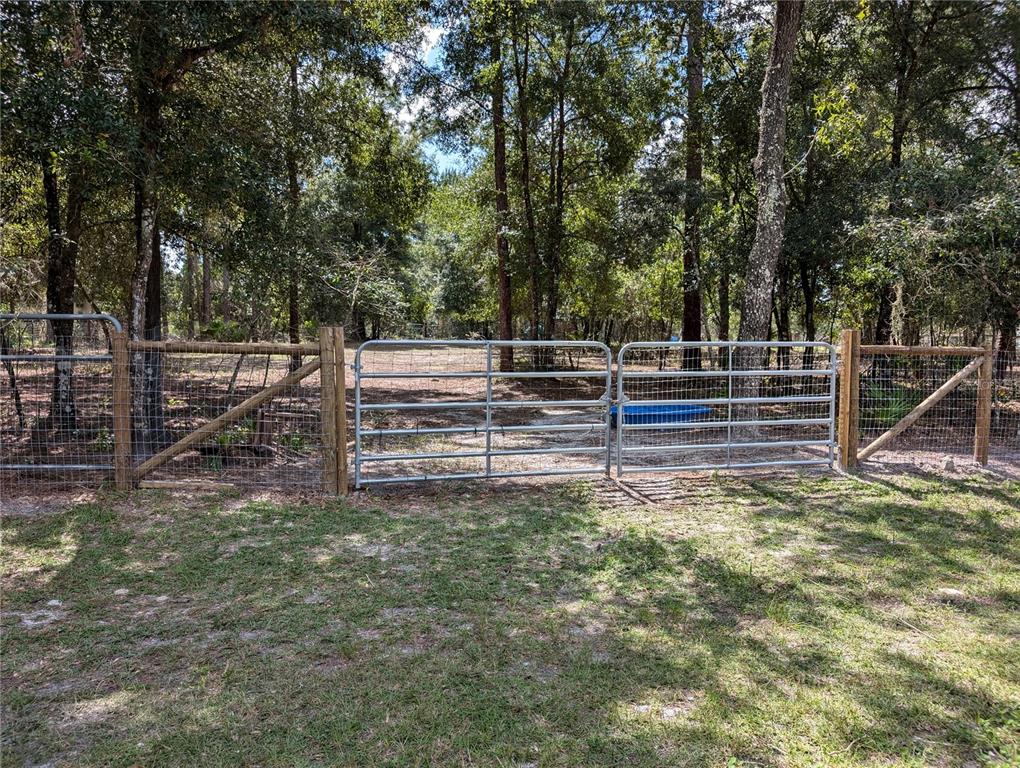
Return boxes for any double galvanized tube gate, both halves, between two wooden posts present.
[354,341,836,488]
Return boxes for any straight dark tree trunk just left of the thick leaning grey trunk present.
[680,0,705,368]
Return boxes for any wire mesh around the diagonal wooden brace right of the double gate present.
[860,354,978,460]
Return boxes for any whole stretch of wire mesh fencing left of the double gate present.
[0,314,323,498]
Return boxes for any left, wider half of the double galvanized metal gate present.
[354,341,612,488]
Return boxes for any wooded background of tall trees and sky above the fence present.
[0,0,1020,359]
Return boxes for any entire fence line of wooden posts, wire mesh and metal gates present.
[0,313,1020,494]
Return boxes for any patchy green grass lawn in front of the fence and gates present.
[2,475,1020,767]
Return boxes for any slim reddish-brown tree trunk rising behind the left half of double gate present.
[492,32,513,371]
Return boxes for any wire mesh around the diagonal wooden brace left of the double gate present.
[133,352,323,491]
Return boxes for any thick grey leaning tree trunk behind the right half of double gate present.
[736,0,804,420]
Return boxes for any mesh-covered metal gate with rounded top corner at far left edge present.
[0,317,114,498]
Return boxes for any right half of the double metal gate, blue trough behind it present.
[612,342,836,475]
